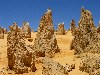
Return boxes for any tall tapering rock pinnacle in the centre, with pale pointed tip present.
[34,9,59,57]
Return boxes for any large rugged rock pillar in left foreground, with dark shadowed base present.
[7,22,36,74]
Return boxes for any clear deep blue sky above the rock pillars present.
[0,0,100,31]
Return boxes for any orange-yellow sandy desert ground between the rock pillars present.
[0,30,88,75]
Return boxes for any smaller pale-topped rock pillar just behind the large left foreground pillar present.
[22,21,31,38]
